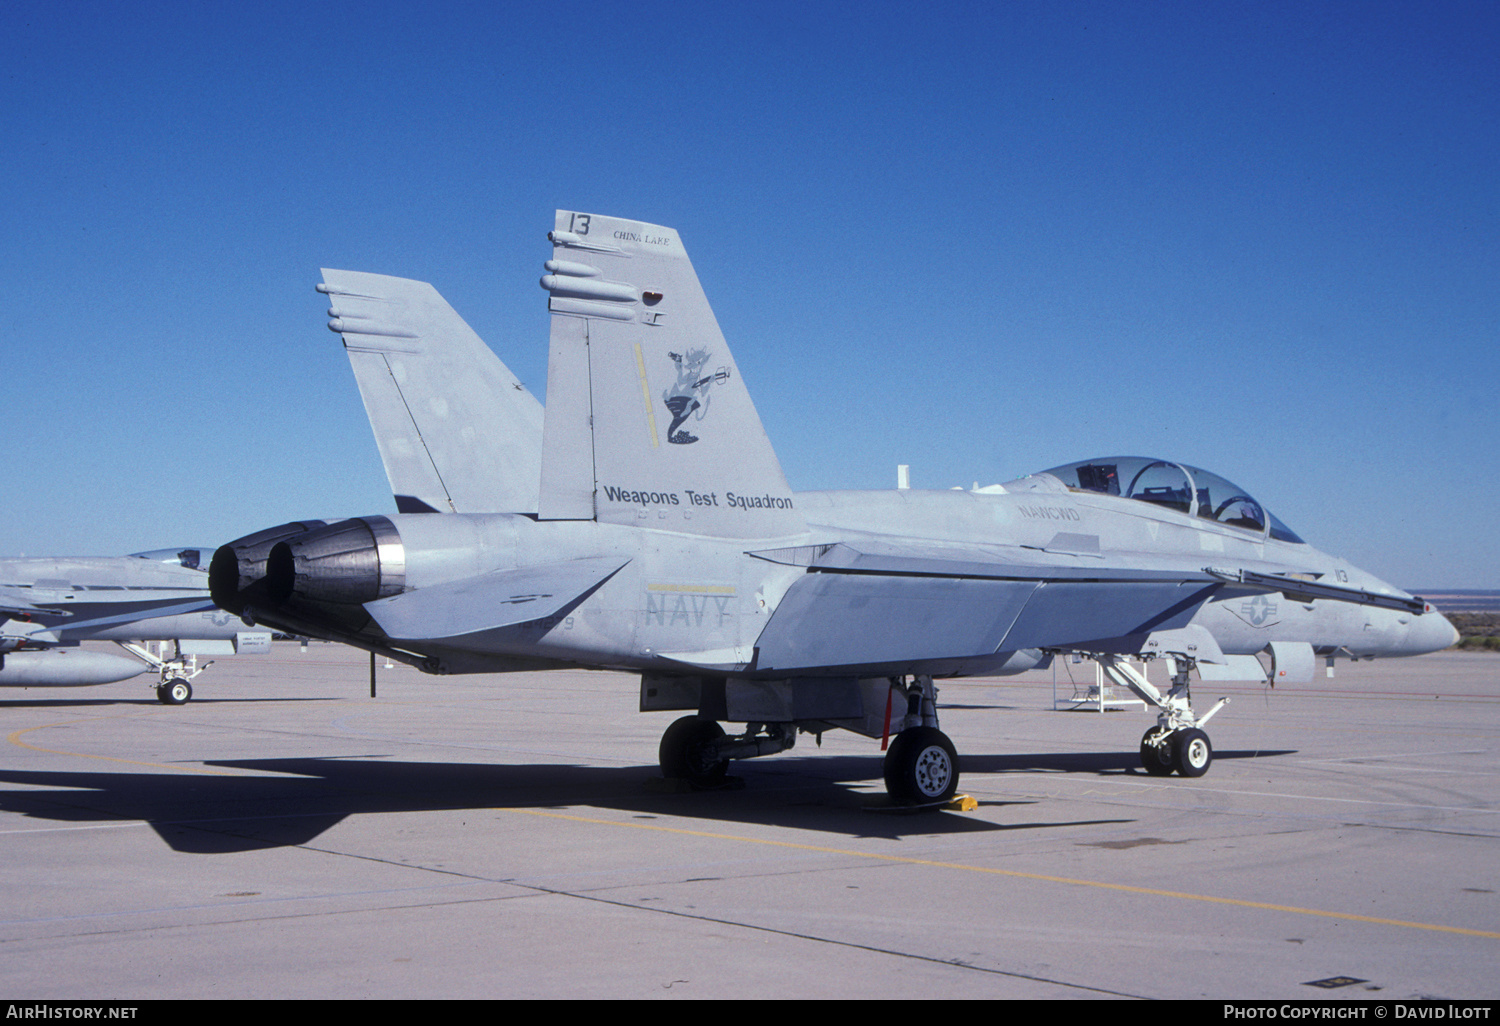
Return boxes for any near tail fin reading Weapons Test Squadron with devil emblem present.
[540,210,806,539]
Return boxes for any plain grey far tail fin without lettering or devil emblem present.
[318,269,542,513]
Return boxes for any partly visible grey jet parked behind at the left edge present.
[0,546,273,705]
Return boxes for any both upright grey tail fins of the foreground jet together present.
[318,210,806,539]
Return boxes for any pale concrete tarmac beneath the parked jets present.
[0,644,1500,1001]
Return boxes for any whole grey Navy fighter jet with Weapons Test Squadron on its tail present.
[210,212,1455,804]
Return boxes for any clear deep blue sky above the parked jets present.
[0,0,1500,588]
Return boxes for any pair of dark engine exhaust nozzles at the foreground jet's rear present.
[209,516,407,630]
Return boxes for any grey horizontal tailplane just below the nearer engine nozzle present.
[365,557,630,641]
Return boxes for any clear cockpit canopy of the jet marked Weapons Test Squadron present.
[1043,456,1305,545]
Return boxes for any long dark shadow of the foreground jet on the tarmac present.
[0,741,1230,854]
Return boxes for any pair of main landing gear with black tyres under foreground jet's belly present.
[657,677,959,806]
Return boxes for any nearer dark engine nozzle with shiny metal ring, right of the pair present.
[266,516,407,606]
